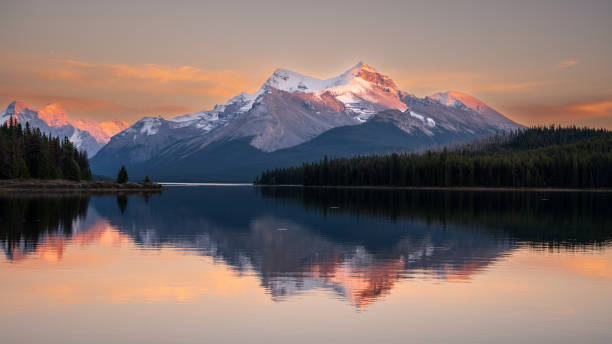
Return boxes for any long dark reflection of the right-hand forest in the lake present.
[258,187,612,248]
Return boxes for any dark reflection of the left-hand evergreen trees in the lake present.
[0,194,90,259]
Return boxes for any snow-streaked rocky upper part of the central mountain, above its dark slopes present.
[98,62,517,161]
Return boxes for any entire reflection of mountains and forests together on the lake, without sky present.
[0,187,612,308]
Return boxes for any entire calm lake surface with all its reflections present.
[0,186,612,343]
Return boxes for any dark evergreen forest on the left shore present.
[0,118,91,181]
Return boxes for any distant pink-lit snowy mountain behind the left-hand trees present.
[0,101,129,156]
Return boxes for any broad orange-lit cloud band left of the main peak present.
[0,52,261,122]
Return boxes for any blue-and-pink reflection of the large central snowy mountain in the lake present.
[85,188,514,307]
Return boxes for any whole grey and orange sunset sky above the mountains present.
[0,0,612,129]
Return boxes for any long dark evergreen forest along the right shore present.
[255,126,612,187]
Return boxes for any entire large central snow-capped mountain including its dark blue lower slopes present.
[91,62,521,181]
